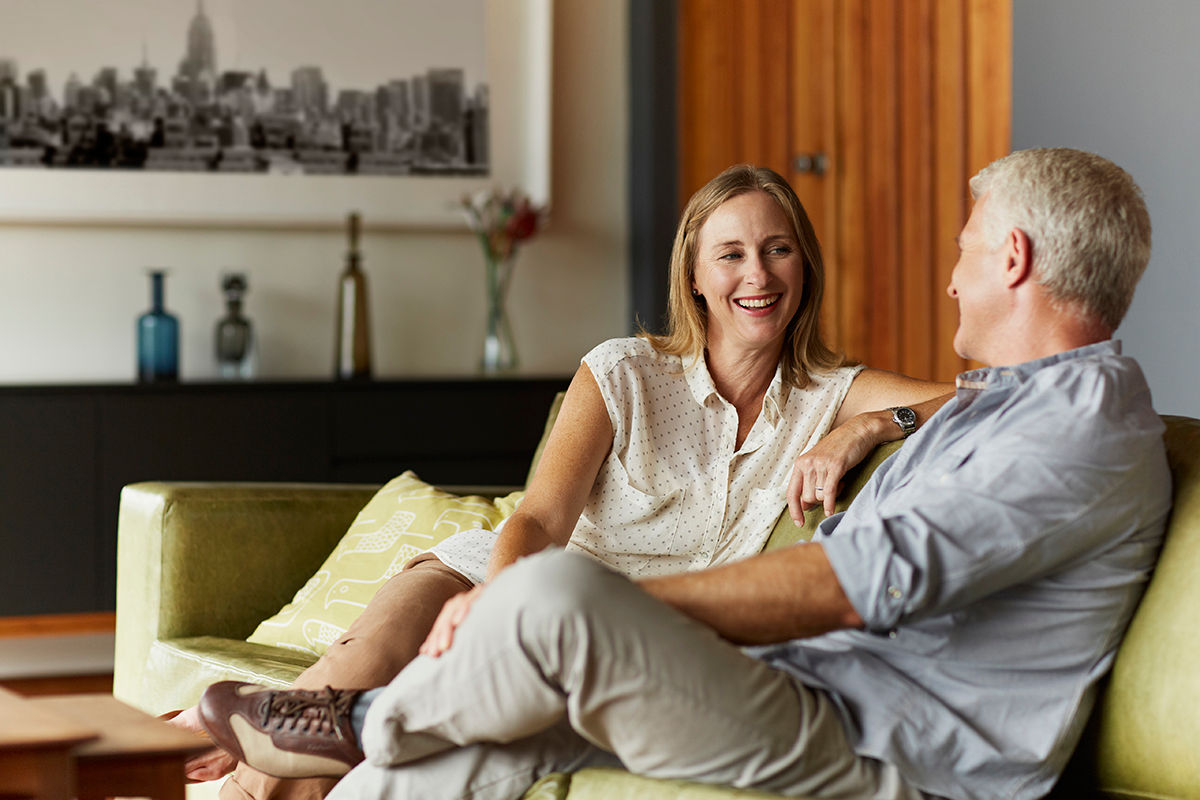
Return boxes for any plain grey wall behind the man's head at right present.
[1013,0,1200,416]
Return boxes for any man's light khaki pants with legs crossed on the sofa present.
[330,552,922,800]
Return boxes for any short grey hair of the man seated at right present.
[971,148,1150,330]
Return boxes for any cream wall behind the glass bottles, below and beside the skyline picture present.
[0,0,629,384]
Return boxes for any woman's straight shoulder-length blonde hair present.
[640,164,845,389]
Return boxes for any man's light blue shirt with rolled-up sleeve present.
[751,342,1171,800]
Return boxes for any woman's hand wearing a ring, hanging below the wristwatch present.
[787,414,878,525]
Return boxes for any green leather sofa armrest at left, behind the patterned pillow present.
[113,482,378,700]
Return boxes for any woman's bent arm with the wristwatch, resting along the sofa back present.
[787,369,954,524]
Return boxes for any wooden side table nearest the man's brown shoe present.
[26,694,212,800]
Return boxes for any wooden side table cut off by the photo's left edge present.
[0,688,100,800]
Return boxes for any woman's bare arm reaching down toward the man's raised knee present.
[420,365,613,658]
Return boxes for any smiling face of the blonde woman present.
[692,192,804,353]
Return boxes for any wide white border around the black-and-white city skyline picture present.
[0,0,553,230]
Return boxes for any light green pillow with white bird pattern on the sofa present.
[247,473,523,656]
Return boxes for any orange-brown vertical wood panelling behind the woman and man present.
[679,0,1012,380]
